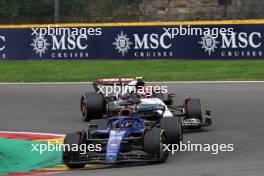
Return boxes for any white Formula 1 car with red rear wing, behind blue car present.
[80,77,212,128]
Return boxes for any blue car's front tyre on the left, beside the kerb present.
[63,132,85,169]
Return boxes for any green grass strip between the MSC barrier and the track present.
[0,59,264,82]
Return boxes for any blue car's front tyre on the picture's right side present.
[144,128,169,162]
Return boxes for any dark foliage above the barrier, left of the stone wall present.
[0,0,141,24]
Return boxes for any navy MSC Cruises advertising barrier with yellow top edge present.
[0,20,264,60]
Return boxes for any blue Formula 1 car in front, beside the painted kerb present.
[63,105,182,168]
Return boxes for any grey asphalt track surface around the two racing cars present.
[0,83,264,176]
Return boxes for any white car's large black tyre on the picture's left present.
[80,92,104,122]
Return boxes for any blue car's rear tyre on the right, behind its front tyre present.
[160,117,183,144]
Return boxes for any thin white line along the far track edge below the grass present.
[0,81,264,85]
